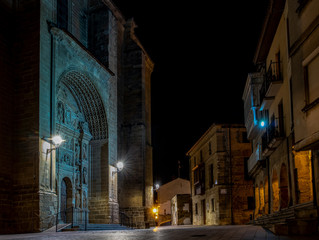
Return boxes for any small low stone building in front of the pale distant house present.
[171,194,192,225]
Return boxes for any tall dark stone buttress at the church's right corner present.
[119,21,153,227]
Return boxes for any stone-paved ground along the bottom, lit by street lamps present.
[0,225,319,240]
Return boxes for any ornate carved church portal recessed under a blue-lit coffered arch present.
[56,71,114,223]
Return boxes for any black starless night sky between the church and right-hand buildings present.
[113,0,267,184]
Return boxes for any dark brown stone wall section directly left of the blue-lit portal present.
[12,0,40,232]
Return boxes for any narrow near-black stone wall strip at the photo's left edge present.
[0,0,15,233]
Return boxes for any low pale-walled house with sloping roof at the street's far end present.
[157,178,191,223]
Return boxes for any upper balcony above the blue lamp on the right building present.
[259,62,283,110]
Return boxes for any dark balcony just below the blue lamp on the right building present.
[261,119,284,157]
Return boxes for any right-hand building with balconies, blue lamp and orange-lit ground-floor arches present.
[243,0,319,234]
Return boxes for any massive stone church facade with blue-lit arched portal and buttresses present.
[0,0,154,233]
